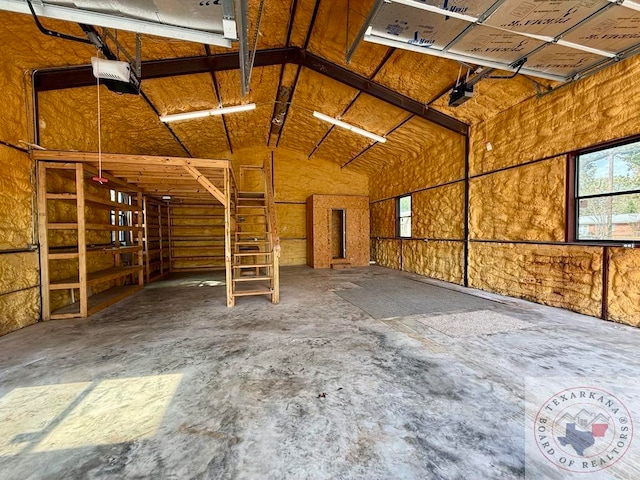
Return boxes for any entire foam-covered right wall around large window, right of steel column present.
[470,53,640,325]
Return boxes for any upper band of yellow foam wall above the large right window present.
[471,58,640,175]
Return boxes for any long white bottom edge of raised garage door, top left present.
[0,0,231,48]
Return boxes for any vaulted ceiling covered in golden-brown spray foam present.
[0,0,552,173]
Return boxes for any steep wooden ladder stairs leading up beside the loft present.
[231,163,280,304]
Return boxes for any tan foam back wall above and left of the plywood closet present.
[232,147,369,265]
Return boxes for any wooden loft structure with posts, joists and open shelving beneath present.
[31,150,237,312]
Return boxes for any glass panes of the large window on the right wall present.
[576,142,640,241]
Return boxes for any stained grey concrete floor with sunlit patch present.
[0,267,640,480]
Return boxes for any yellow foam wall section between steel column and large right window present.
[469,157,565,242]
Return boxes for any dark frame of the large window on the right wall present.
[565,135,640,247]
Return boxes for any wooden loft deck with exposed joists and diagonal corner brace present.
[32,150,235,206]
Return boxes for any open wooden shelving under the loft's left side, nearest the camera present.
[38,161,144,320]
